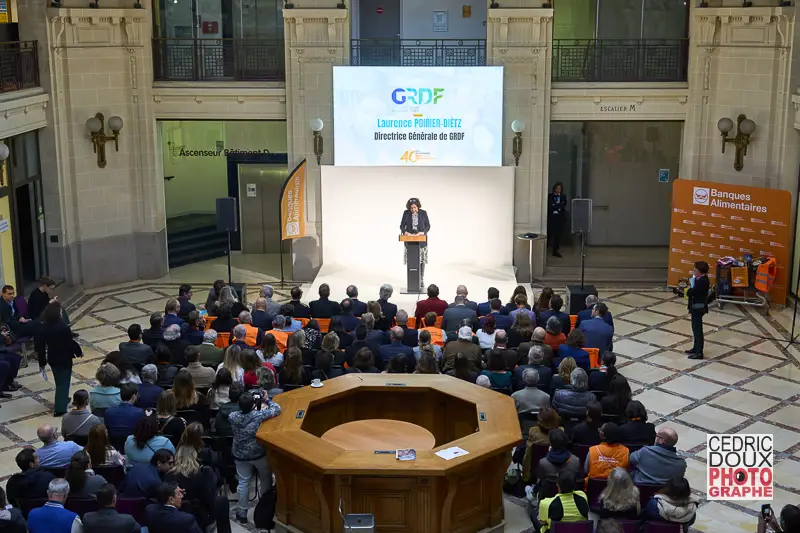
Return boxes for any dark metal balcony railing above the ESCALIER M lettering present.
[553,39,689,82]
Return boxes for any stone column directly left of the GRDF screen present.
[283,6,350,280]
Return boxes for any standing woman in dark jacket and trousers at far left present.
[33,301,83,416]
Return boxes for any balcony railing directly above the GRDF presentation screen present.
[350,39,486,67]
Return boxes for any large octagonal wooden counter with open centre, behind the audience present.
[258,374,521,533]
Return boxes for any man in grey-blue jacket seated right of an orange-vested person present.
[630,427,686,485]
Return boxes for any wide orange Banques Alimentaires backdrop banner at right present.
[668,180,792,305]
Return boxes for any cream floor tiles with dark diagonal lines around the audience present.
[0,283,800,533]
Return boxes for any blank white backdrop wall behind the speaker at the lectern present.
[321,166,514,269]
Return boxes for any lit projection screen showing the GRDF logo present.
[333,67,503,167]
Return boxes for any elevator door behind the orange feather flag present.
[238,163,289,254]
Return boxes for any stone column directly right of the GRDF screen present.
[486,3,553,275]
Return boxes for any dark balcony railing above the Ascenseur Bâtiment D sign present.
[153,37,286,81]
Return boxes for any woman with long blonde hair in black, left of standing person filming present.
[164,444,231,533]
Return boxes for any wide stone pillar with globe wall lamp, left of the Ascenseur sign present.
[19,0,162,287]
